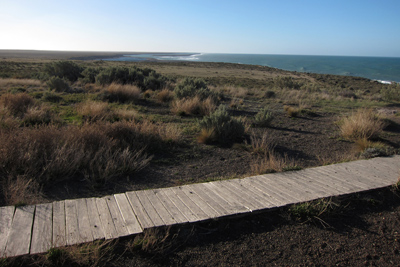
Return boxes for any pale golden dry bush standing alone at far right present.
[339,109,385,140]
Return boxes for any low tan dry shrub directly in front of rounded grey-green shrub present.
[171,96,217,116]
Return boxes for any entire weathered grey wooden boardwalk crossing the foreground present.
[0,156,400,257]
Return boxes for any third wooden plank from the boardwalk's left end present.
[30,203,53,254]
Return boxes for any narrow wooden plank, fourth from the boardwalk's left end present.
[53,200,67,247]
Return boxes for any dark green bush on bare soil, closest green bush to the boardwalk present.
[199,105,245,144]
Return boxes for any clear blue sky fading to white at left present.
[0,0,400,57]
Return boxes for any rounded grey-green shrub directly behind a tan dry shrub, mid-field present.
[174,78,217,100]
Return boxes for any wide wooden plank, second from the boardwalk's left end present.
[4,205,35,257]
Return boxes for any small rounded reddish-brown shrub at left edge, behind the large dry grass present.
[0,93,35,117]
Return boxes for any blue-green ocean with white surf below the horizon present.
[106,53,400,83]
